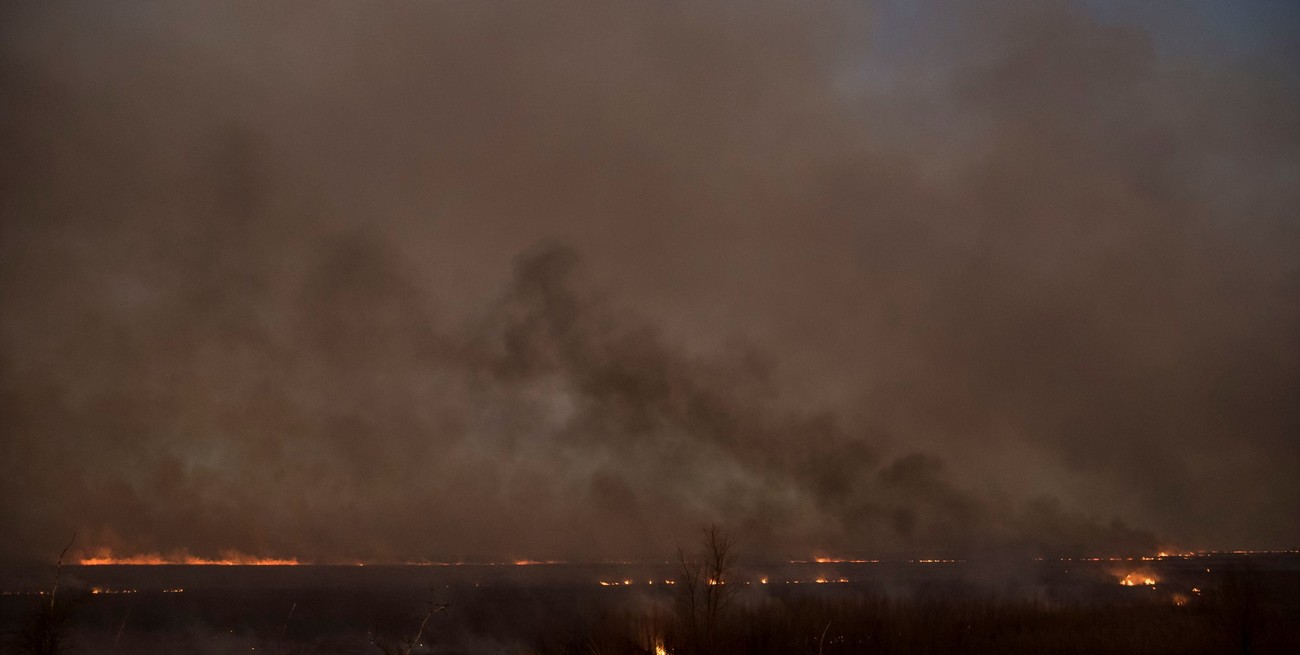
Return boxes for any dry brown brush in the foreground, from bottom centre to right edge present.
[582,584,1300,655]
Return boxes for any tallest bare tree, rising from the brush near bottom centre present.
[677,525,740,654]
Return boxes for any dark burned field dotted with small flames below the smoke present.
[0,554,1300,654]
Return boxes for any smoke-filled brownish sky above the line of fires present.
[0,0,1300,561]
